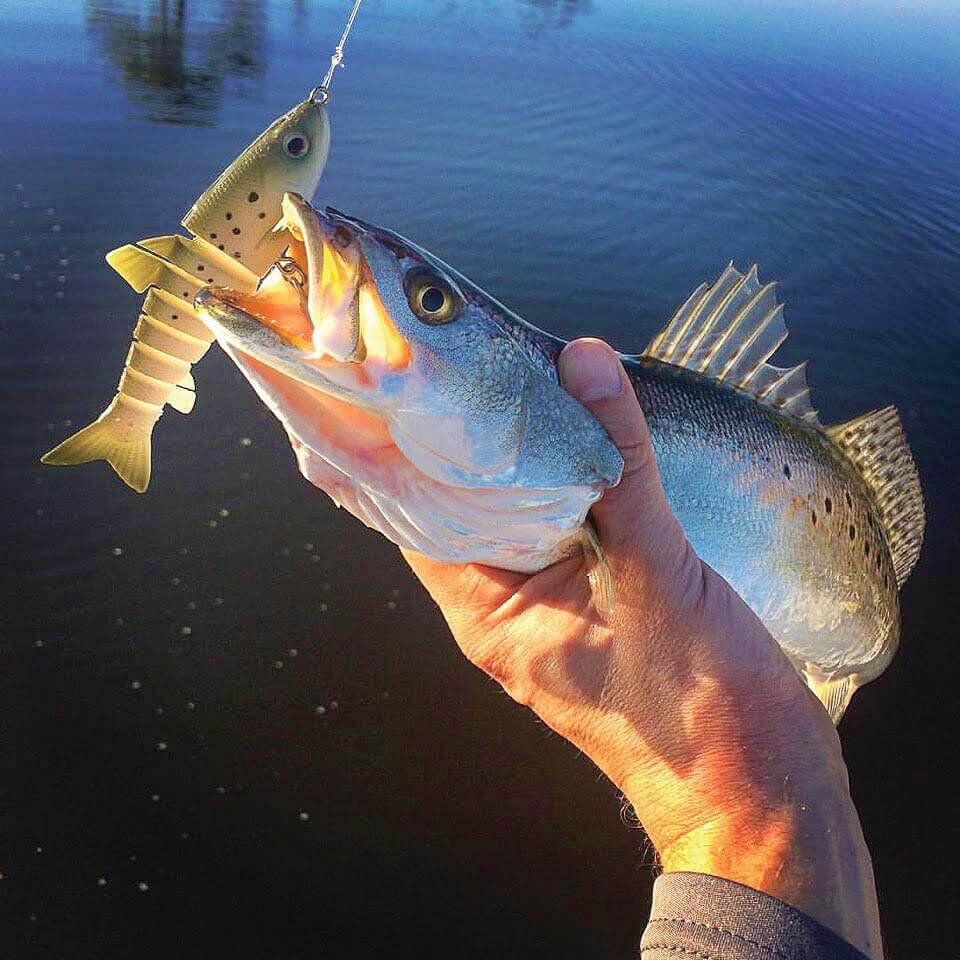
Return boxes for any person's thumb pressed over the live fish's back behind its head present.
[559,337,685,552]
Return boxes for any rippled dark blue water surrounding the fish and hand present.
[0,0,960,958]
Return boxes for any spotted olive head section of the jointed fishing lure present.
[182,97,330,275]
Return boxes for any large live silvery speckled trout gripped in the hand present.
[196,195,924,720]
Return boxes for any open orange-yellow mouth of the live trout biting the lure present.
[195,193,412,389]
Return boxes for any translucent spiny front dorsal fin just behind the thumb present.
[642,262,820,426]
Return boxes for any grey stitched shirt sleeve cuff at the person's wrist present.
[640,873,869,960]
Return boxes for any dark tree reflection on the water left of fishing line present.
[86,0,266,126]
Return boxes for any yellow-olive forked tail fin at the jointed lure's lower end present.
[40,394,160,493]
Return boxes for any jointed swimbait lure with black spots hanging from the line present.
[41,95,330,493]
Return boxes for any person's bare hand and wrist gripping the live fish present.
[404,340,881,957]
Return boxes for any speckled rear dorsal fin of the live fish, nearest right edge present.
[826,407,926,586]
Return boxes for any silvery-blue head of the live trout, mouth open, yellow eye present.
[197,194,623,569]
